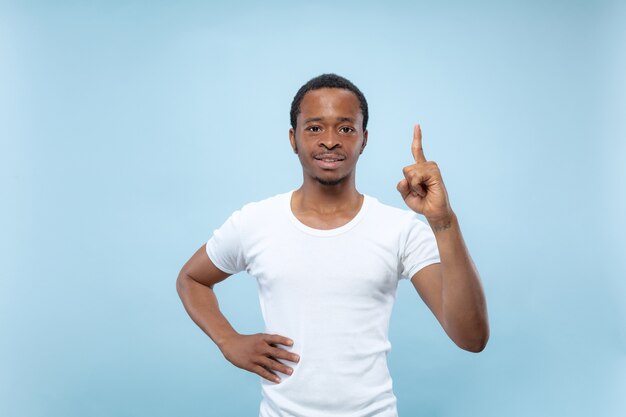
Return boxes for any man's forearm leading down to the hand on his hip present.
[176,272,237,349]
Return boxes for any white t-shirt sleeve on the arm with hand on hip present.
[206,211,246,275]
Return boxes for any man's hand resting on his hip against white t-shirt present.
[220,333,300,384]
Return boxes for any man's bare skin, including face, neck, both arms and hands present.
[176,88,489,383]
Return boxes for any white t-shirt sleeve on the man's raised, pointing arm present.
[400,214,440,279]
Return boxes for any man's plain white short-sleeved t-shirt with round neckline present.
[206,192,439,417]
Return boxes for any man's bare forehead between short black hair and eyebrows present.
[298,88,363,120]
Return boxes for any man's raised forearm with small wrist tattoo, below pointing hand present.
[431,213,489,351]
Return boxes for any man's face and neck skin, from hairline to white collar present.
[289,88,367,229]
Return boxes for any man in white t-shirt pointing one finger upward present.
[177,74,489,417]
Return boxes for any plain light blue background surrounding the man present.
[0,1,626,417]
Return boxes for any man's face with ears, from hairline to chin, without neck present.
[289,88,367,185]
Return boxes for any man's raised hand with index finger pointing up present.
[397,124,453,227]
